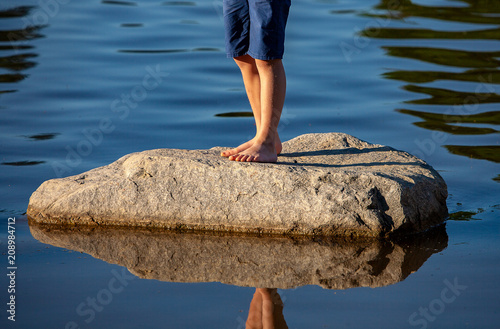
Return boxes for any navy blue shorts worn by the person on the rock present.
[223,0,290,60]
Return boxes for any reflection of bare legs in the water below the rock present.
[246,288,288,329]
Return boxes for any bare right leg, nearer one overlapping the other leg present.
[229,59,286,162]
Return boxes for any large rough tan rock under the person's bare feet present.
[28,133,447,236]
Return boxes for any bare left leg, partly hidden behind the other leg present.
[221,55,281,157]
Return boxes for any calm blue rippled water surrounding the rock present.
[0,0,500,329]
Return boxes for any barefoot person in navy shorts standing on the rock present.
[221,0,290,162]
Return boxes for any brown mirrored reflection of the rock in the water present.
[30,223,448,289]
